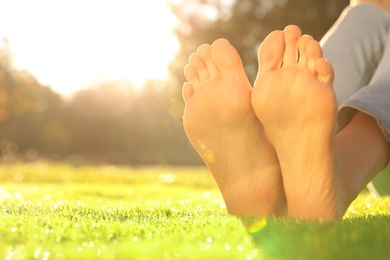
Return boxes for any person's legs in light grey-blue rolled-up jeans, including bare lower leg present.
[322,1,390,205]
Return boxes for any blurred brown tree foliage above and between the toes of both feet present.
[170,0,349,82]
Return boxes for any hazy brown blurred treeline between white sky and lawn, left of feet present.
[0,40,198,164]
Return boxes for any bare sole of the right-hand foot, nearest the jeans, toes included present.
[252,26,345,219]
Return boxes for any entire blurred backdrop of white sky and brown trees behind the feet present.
[0,0,349,165]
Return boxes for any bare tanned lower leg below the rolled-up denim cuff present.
[336,112,390,204]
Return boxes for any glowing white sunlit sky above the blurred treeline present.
[0,0,178,95]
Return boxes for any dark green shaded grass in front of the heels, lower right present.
[250,216,390,259]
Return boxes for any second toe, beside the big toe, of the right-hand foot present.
[283,25,301,66]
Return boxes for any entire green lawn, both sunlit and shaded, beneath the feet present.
[0,163,390,259]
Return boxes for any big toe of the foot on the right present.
[258,31,285,72]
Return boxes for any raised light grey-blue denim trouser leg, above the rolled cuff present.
[320,4,390,105]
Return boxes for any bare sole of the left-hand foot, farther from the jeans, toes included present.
[183,39,285,216]
